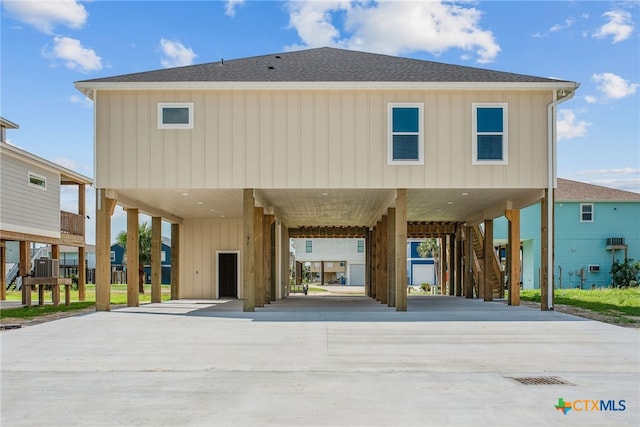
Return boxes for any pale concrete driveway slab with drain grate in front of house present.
[0,295,640,427]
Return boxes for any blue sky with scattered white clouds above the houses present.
[0,0,640,242]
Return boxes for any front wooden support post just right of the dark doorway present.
[242,188,256,311]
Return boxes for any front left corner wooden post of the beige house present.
[96,188,116,311]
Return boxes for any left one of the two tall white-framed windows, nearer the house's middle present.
[387,103,424,165]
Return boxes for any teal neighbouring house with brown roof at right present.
[494,178,640,289]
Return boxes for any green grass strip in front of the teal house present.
[520,288,640,318]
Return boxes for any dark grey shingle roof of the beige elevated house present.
[83,47,576,83]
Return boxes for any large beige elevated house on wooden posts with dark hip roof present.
[75,48,579,311]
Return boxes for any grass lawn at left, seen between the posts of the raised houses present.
[0,284,171,319]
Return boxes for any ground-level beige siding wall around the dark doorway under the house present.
[180,219,243,298]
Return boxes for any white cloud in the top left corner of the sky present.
[2,0,87,34]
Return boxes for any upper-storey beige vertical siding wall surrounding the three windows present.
[96,91,552,188]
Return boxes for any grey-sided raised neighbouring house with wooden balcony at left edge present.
[0,118,93,299]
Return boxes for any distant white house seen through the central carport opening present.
[293,238,365,286]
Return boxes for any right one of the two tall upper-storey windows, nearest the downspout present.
[471,103,508,165]
